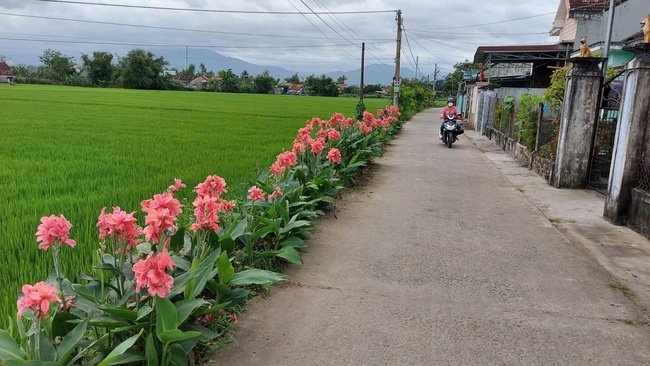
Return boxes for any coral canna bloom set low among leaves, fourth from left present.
[133,248,176,298]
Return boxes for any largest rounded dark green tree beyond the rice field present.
[114,49,167,90]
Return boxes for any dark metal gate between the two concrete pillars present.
[587,74,623,194]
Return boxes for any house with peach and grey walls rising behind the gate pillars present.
[550,0,650,67]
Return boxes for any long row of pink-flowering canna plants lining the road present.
[0,107,401,366]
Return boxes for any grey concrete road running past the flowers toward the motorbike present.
[206,109,650,365]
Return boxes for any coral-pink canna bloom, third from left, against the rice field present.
[97,206,143,253]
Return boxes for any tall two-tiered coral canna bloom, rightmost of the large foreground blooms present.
[190,175,235,232]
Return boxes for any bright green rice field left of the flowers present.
[0,84,390,328]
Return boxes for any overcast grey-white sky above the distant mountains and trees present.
[0,0,560,75]
